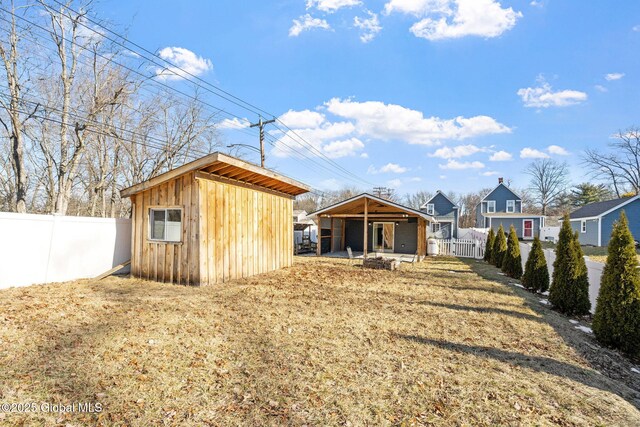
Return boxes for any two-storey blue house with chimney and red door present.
[476,178,545,240]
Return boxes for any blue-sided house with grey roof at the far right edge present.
[569,196,640,246]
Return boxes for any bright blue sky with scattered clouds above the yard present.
[97,0,640,193]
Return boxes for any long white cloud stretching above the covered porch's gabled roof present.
[325,98,511,145]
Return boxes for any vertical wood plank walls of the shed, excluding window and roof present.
[131,172,293,285]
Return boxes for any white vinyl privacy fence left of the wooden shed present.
[0,212,131,289]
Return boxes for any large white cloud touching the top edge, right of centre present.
[384,0,522,40]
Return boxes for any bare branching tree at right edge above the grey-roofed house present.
[583,128,640,197]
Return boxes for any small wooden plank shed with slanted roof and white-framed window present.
[121,153,310,285]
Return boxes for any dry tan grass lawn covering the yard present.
[0,257,640,426]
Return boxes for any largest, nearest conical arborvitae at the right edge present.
[593,212,640,358]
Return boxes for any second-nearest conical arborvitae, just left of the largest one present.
[549,215,591,316]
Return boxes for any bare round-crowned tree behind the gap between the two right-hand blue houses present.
[525,159,569,215]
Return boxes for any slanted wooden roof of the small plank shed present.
[120,152,311,197]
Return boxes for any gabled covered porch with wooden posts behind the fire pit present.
[313,193,435,261]
